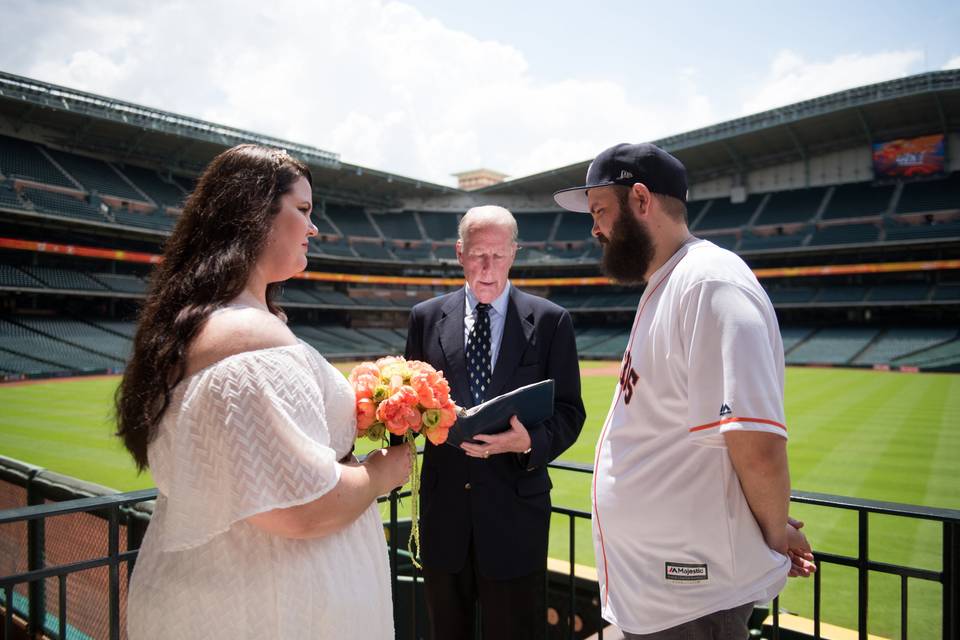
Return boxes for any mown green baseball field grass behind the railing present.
[0,363,960,638]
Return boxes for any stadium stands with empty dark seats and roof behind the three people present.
[0,71,960,379]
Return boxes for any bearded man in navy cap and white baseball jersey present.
[554,144,812,640]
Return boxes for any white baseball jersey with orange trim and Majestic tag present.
[593,238,790,634]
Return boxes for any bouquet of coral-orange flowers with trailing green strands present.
[350,357,459,568]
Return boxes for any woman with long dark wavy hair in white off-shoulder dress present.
[116,145,411,640]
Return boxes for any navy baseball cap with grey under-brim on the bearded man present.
[553,142,687,213]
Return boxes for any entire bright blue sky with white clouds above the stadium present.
[0,0,960,184]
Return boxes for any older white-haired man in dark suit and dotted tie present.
[406,206,586,640]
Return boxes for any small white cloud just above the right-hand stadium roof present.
[743,50,923,114]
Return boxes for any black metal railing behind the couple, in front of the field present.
[0,462,960,640]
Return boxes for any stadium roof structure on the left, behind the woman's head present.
[0,71,460,206]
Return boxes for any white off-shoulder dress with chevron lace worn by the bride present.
[127,343,394,640]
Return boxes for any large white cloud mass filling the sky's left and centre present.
[0,0,716,184]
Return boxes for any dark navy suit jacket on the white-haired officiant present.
[406,286,586,579]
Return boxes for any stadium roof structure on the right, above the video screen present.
[484,70,960,195]
